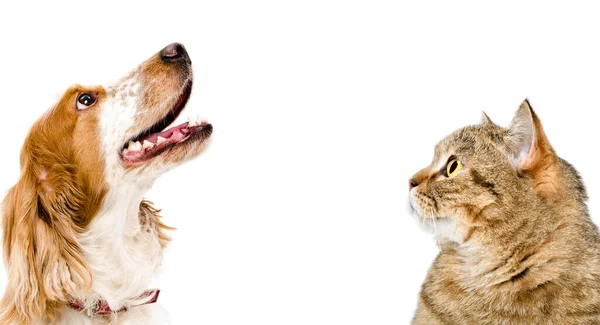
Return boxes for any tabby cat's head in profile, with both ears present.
[409,100,586,243]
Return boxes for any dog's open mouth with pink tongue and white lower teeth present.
[121,81,212,165]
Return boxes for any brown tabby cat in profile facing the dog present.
[409,100,600,325]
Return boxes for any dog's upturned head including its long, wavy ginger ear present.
[0,43,212,323]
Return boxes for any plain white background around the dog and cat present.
[0,0,600,325]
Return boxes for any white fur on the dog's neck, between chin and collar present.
[80,182,162,310]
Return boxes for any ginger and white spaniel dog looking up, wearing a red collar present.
[0,43,213,325]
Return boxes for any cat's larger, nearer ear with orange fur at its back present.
[507,99,560,194]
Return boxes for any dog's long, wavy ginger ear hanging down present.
[0,162,92,324]
